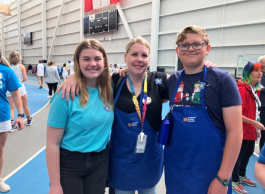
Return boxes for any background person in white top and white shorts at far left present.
[6,51,33,133]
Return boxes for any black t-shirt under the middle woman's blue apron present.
[112,72,167,131]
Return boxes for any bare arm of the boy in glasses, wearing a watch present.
[209,105,243,194]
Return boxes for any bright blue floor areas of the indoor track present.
[6,83,265,194]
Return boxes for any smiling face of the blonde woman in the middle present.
[124,43,150,74]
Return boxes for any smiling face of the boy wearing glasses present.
[176,33,211,71]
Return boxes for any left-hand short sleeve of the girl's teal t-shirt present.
[47,92,69,128]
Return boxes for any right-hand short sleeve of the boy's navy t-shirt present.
[219,72,242,108]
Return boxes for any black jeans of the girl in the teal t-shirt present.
[60,148,109,194]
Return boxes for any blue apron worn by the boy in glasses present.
[164,67,232,194]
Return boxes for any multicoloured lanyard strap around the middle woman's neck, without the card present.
[128,75,147,131]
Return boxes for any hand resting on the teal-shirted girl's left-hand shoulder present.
[57,74,80,102]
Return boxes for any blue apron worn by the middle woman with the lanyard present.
[109,75,163,191]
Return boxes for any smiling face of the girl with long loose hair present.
[79,49,104,85]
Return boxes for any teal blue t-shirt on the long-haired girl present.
[47,88,114,153]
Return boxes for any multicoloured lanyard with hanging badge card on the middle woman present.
[128,76,147,154]
